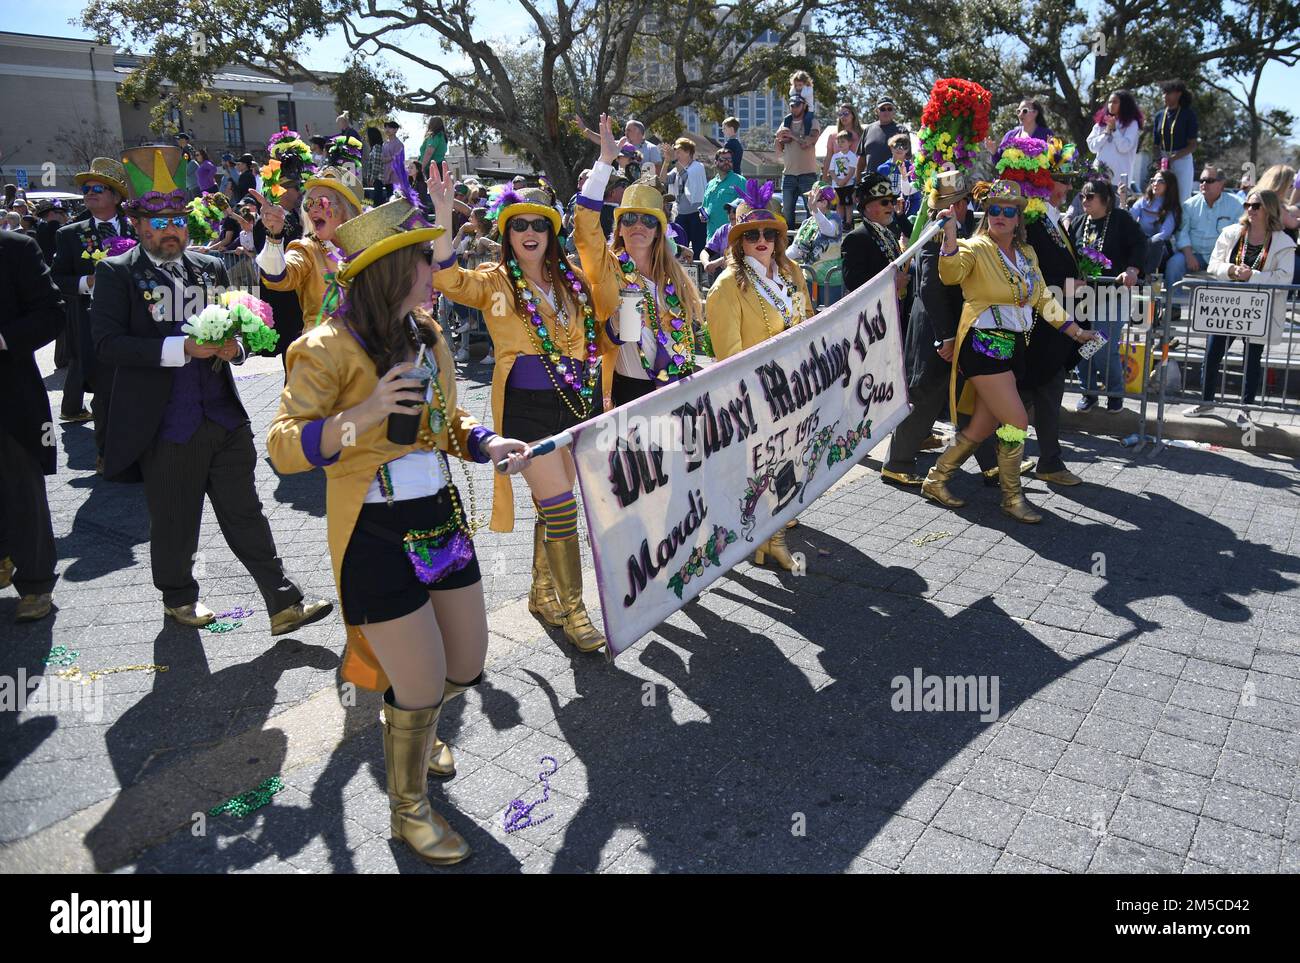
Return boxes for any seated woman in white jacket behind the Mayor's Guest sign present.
[1184,190,1296,428]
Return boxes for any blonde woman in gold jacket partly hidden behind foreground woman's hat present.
[251,168,364,331]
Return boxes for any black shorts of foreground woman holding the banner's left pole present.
[339,489,482,625]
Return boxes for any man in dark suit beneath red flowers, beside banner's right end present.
[880,170,975,487]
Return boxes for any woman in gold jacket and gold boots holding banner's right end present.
[920,181,1095,524]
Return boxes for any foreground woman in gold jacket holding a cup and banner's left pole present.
[267,195,528,864]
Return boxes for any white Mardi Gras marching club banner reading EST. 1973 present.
[573,272,907,655]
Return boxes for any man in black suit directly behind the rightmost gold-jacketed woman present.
[1019,165,1086,485]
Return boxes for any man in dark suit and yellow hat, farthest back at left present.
[51,157,135,472]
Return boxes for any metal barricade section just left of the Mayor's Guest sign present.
[1063,276,1161,452]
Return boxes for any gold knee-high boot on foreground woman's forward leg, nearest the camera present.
[384,690,469,866]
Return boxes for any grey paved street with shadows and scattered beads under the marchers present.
[0,352,1300,873]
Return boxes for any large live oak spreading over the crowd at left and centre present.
[82,0,819,195]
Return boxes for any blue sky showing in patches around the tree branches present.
[17,0,1300,138]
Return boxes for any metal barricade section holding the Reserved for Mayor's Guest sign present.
[1154,278,1300,444]
